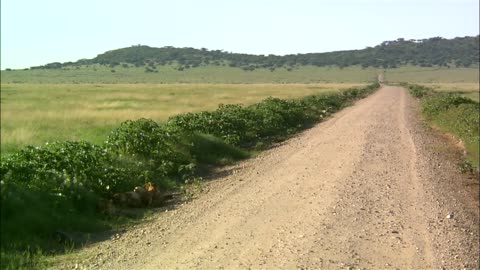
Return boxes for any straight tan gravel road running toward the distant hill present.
[69,86,479,269]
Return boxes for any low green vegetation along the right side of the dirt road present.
[408,85,480,170]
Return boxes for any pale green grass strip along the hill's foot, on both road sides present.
[1,65,479,84]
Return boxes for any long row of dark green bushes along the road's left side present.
[0,84,379,269]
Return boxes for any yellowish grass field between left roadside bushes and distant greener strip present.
[1,83,363,155]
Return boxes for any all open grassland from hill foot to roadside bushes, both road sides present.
[1,65,479,155]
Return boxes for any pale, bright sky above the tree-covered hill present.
[1,0,479,69]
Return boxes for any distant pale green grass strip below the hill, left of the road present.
[1,65,377,84]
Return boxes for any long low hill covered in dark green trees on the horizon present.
[31,36,479,72]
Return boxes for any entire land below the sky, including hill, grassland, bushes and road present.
[0,33,480,269]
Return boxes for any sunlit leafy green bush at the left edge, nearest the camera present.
[0,141,110,198]
